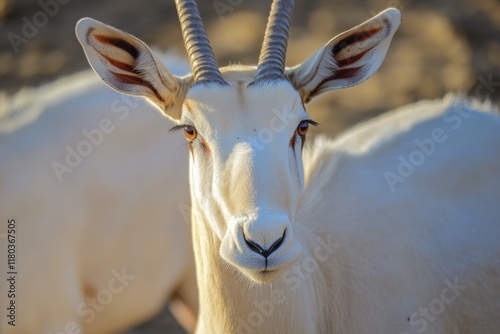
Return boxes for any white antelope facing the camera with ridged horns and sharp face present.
[76,0,500,333]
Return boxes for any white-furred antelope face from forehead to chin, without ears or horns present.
[180,74,310,281]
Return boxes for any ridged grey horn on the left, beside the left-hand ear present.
[175,0,227,85]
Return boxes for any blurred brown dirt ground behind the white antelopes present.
[0,0,500,334]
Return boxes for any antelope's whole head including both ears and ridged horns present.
[76,0,401,282]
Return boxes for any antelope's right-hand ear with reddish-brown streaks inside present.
[286,8,401,102]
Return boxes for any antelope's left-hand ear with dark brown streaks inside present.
[76,18,190,120]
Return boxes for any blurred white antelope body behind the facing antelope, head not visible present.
[0,57,197,334]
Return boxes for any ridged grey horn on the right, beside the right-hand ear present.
[254,0,294,82]
